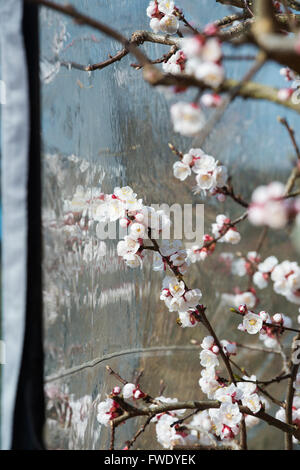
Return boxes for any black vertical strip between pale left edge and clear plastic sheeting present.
[12,2,44,450]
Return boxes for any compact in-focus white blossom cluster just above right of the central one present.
[173,148,228,194]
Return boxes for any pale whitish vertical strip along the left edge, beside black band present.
[0,0,29,449]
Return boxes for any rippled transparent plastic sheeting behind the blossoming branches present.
[41,0,295,449]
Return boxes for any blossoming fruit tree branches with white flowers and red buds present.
[36,0,300,450]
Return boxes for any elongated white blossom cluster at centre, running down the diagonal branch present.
[88,186,202,327]
